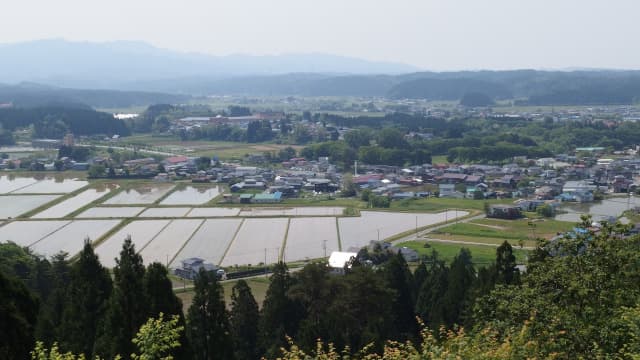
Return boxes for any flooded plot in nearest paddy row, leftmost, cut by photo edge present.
[0,220,71,246]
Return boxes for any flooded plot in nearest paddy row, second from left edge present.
[31,220,120,257]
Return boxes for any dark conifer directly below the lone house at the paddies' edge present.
[187,269,233,360]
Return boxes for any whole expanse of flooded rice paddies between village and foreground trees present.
[0,176,468,267]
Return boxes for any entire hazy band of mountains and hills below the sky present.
[0,40,640,108]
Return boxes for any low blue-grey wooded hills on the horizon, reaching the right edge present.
[190,70,640,105]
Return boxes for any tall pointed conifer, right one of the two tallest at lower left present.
[96,237,149,359]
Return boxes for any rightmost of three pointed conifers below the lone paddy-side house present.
[258,262,296,357]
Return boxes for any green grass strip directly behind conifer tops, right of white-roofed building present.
[398,241,527,266]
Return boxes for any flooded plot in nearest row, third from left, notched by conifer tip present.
[96,220,170,268]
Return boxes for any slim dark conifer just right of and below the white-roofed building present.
[384,252,418,340]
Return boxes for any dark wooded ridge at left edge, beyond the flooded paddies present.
[0,107,130,138]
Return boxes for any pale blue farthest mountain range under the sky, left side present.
[0,39,418,89]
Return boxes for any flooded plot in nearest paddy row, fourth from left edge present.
[140,219,204,265]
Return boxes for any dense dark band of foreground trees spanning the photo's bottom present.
[0,219,640,359]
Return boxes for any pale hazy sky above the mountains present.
[0,0,640,70]
